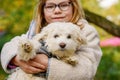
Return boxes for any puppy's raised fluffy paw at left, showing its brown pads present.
[17,38,36,61]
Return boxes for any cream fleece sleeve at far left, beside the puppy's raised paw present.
[1,34,26,73]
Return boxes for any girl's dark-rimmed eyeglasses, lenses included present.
[44,2,72,12]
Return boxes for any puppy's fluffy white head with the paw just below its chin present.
[34,22,86,66]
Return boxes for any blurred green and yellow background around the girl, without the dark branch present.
[0,0,120,80]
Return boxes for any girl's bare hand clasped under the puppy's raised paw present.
[12,54,48,74]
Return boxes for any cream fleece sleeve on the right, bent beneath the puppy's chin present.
[48,22,102,80]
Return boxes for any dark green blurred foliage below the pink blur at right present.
[95,47,120,80]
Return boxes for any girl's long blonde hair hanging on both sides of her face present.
[34,0,84,34]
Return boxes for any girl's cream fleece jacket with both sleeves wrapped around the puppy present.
[1,20,102,80]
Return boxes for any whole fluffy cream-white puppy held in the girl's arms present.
[8,22,86,80]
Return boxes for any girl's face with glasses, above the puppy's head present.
[44,0,73,23]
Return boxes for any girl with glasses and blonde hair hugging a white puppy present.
[1,0,102,80]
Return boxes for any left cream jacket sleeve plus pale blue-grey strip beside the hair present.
[1,21,35,73]
